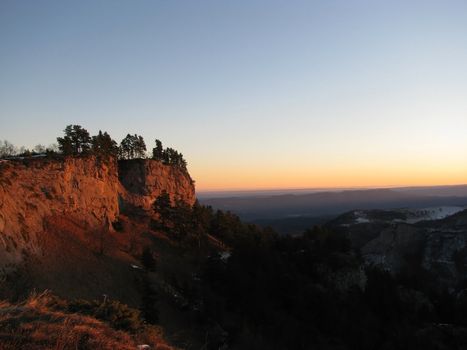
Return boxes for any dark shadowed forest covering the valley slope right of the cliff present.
[150,194,467,350]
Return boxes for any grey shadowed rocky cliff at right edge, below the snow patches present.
[328,207,467,290]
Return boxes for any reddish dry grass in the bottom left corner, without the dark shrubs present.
[0,292,173,350]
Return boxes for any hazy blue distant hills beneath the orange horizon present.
[199,185,467,233]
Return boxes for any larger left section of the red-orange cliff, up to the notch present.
[0,157,119,273]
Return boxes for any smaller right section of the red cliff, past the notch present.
[118,159,196,210]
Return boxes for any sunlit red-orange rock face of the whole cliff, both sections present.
[0,157,195,278]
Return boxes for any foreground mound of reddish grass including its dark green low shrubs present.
[0,292,174,350]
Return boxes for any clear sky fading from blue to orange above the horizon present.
[0,0,467,191]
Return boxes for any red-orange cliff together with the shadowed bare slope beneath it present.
[0,157,195,305]
